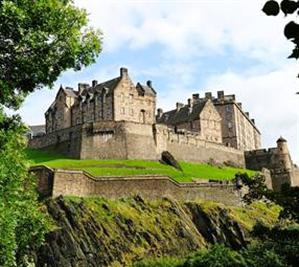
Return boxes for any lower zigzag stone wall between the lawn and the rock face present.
[32,167,241,205]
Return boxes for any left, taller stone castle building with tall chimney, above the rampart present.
[45,68,156,133]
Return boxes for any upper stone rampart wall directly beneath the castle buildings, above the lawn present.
[29,121,245,167]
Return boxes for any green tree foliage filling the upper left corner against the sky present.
[0,0,101,108]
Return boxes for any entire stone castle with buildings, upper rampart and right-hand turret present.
[29,68,297,192]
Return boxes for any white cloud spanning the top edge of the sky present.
[75,0,290,64]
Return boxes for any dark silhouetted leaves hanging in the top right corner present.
[262,0,299,59]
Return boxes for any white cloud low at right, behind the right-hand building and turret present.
[206,62,299,163]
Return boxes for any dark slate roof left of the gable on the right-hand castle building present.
[157,101,207,125]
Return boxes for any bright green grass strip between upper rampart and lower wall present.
[26,149,254,182]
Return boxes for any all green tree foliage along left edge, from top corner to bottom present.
[0,0,101,267]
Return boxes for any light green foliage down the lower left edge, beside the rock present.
[0,109,46,266]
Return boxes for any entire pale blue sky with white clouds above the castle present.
[15,0,299,163]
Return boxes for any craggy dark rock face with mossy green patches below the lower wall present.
[35,196,274,267]
